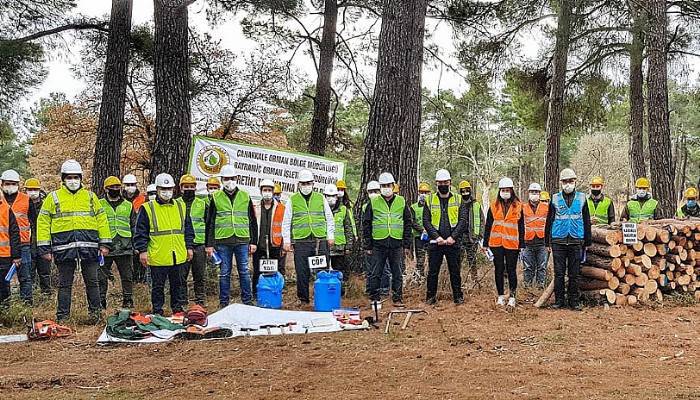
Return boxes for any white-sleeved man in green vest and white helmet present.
[282,169,335,307]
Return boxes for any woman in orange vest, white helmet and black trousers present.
[484,178,525,307]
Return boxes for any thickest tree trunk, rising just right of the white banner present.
[358,0,427,212]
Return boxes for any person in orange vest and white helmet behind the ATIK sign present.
[253,179,287,298]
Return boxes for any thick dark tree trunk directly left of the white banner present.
[150,0,191,182]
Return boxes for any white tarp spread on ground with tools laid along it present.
[97,304,342,343]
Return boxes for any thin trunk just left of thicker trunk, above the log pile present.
[629,0,647,180]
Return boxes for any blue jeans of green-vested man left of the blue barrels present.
[216,244,253,306]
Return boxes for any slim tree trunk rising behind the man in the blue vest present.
[544,0,571,193]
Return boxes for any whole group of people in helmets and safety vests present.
[0,160,700,321]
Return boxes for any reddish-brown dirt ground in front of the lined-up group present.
[0,262,700,400]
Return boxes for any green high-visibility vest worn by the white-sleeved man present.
[290,192,328,240]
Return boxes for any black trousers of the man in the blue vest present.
[552,243,582,306]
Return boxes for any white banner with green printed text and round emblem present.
[189,136,345,199]
